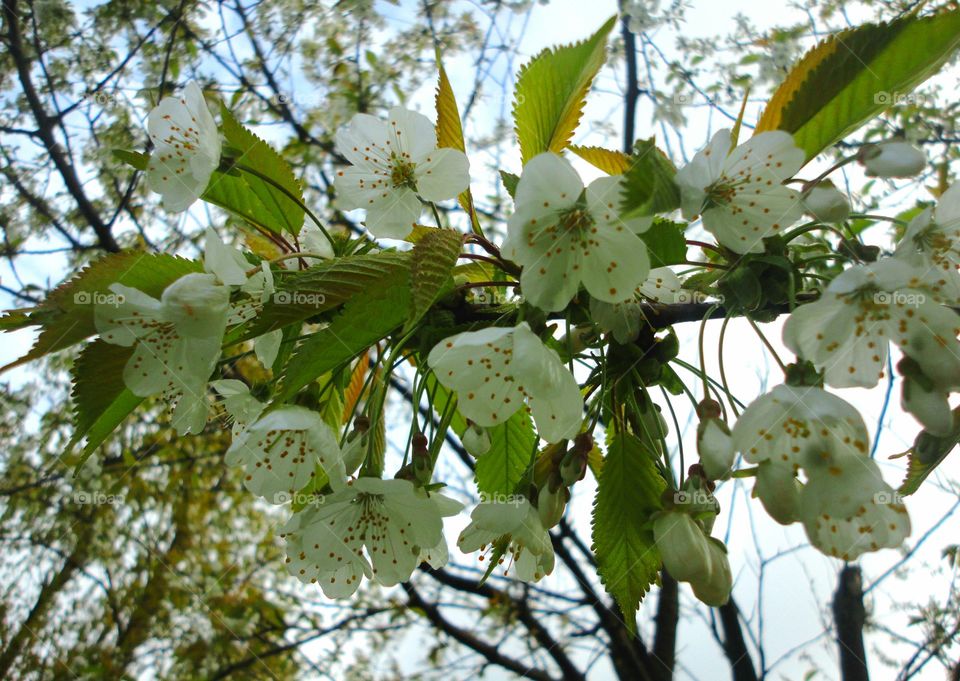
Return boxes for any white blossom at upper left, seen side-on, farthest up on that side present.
[146,81,220,213]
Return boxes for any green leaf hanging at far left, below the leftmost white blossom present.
[67,339,144,462]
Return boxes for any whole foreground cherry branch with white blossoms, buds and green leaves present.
[3,10,960,621]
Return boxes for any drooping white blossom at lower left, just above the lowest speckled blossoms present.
[225,406,345,504]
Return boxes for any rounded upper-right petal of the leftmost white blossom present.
[160,272,230,338]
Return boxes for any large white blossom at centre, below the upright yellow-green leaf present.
[502,152,652,312]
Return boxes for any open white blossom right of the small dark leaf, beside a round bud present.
[674,130,804,253]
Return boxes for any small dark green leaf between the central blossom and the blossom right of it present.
[620,137,680,218]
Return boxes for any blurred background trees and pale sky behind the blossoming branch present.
[0,0,960,681]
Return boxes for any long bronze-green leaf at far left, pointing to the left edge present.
[0,251,203,372]
